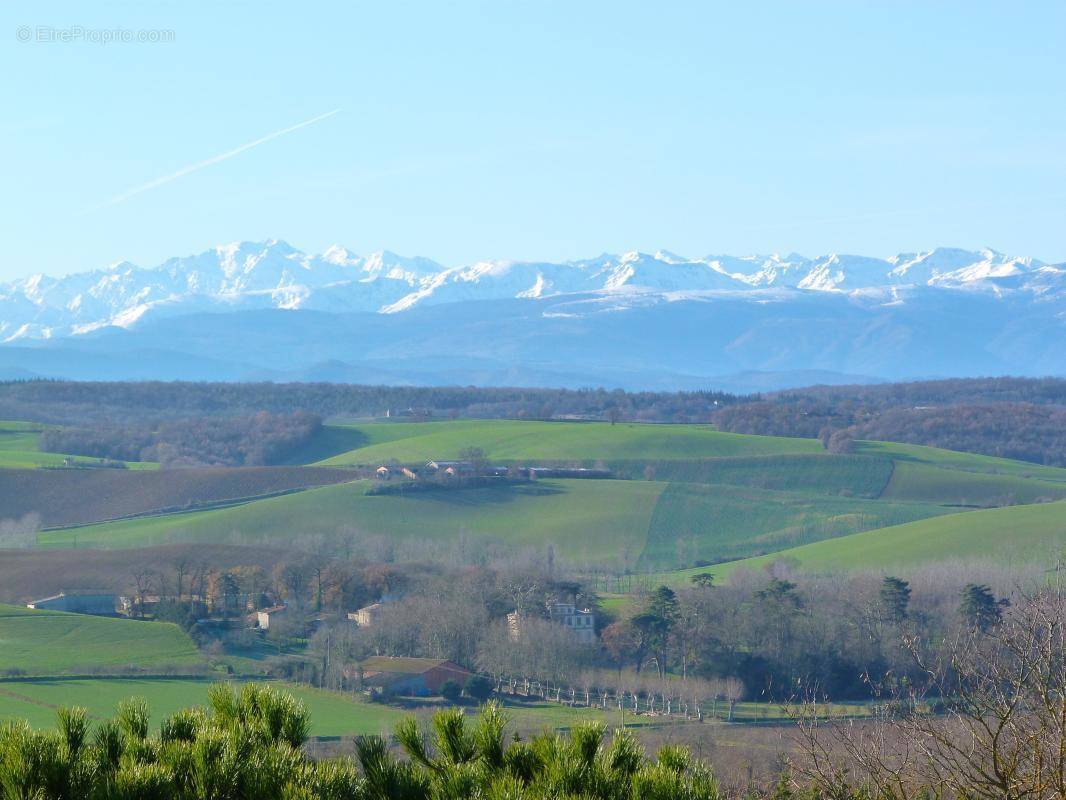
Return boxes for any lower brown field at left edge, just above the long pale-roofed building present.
[0,544,290,605]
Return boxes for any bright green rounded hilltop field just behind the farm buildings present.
[311,419,822,465]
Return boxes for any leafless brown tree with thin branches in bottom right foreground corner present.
[798,589,1066,800]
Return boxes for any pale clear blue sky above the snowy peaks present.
[0,0,1066,278]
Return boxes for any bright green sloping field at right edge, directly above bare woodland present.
[655,502,1066,585]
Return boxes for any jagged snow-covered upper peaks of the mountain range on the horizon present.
[0,240,1066,342]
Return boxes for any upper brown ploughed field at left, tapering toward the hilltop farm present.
[0,467,356,528]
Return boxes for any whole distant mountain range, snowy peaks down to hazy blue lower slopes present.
[0,241,1066,393]
